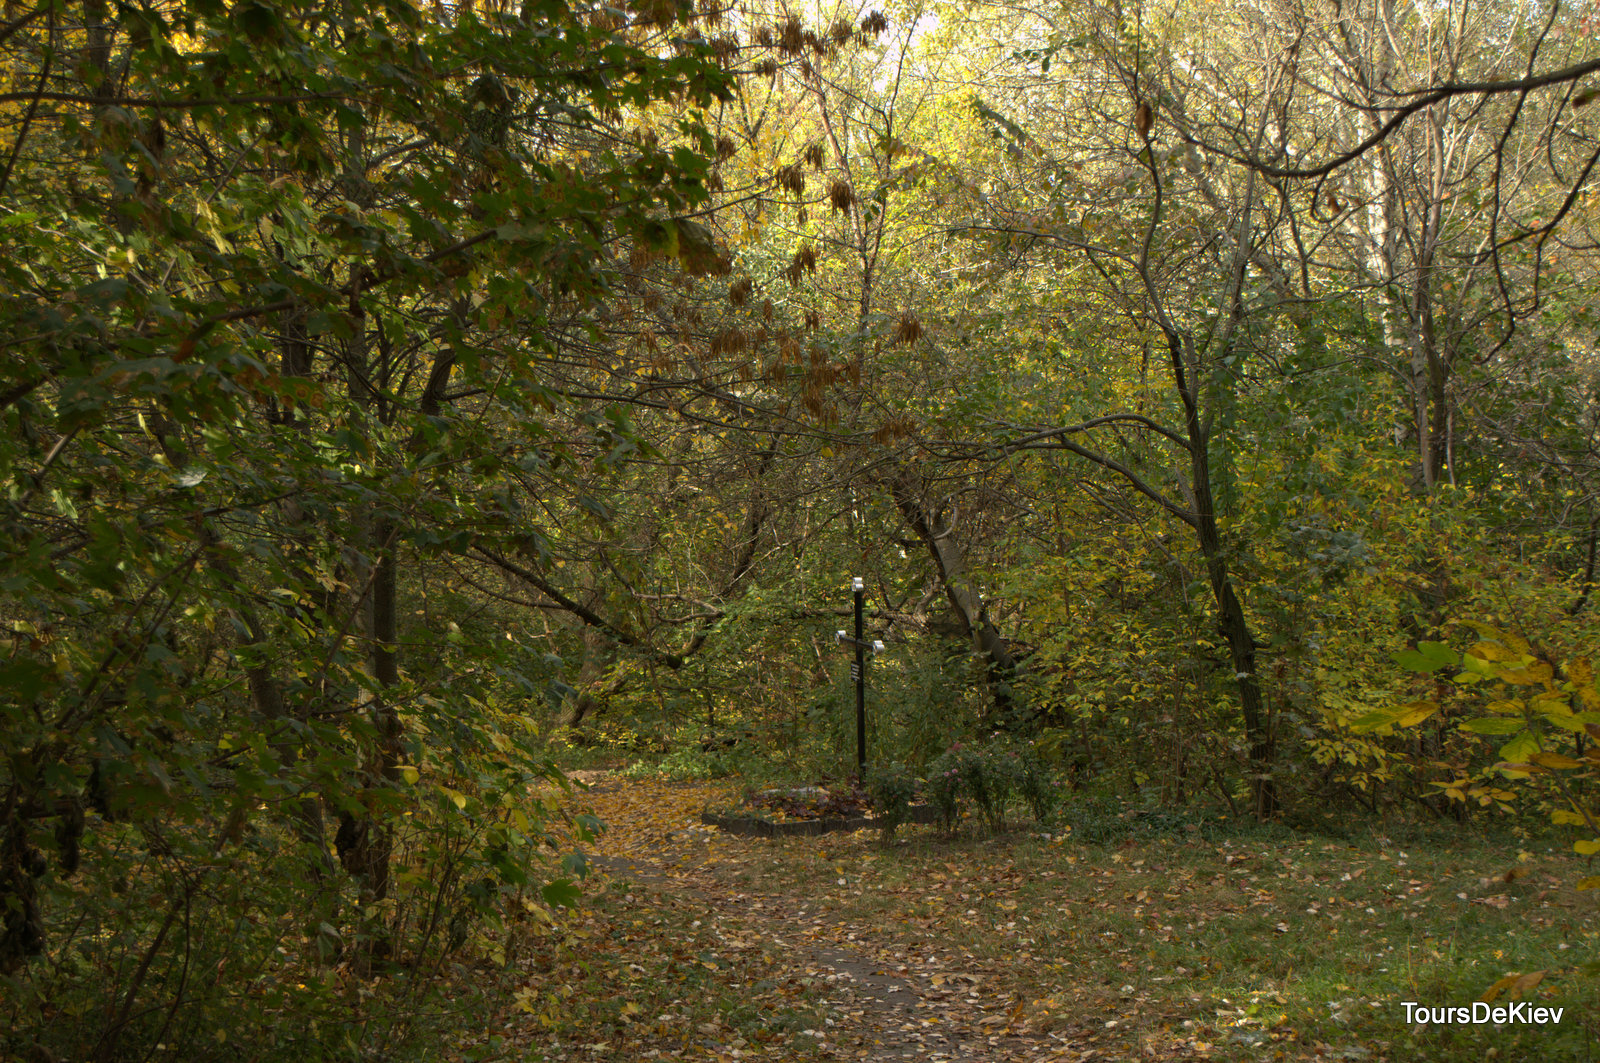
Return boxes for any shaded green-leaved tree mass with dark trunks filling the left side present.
[0,2,728,1060]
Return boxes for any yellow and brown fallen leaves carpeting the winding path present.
[518,776,1120,1063]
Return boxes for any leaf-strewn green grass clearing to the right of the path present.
[704,805,1600,1060]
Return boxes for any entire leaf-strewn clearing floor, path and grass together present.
[451,773,1600,1063]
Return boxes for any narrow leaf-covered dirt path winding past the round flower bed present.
[566,775,1096,1063]
